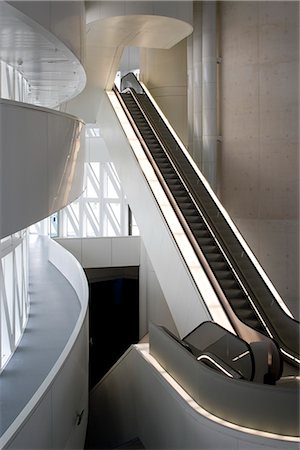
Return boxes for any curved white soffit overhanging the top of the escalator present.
[86,14,193,89]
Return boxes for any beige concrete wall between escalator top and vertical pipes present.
[140,39,188,145]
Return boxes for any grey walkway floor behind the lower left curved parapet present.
[0,236,80,436]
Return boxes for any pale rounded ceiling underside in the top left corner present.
[0,1,86,108]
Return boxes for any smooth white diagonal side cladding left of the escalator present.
[98,92,210,336]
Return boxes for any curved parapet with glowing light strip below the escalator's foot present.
[87,343,300,450]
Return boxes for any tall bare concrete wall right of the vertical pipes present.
[219,2,299,315]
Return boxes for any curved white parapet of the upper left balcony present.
[0,99,85,238]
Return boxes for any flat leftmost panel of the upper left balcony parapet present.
[0,101,48,237]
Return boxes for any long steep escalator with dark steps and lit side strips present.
[115,74,299,372]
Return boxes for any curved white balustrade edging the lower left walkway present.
[0,237,88,449]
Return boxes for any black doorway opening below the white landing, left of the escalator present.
[86,267,139,389]
